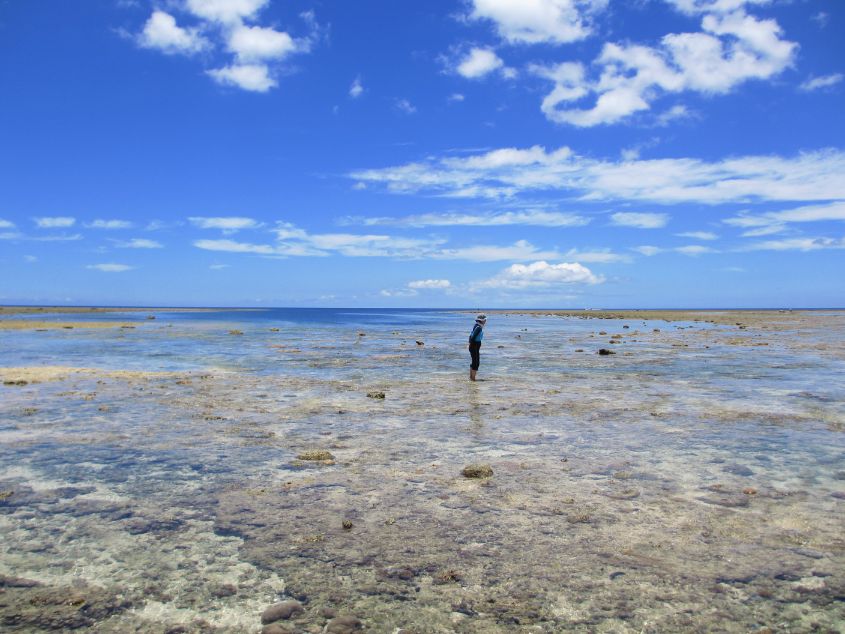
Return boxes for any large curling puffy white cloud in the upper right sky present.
[529,6,797,127]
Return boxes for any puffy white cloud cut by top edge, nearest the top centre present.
[470,0,608,44]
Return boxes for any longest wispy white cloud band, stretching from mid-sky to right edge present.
[349,145,845,204]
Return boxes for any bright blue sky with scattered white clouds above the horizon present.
[0,0,845,308]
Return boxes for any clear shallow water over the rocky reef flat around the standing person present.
[0,310,845,633]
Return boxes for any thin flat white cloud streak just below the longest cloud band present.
[344,209,590,227]
